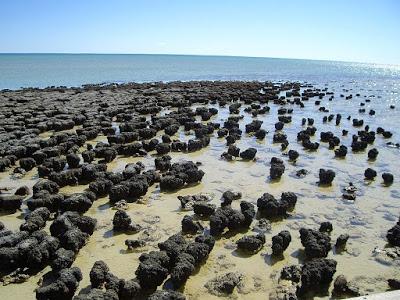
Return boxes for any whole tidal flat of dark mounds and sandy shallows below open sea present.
[0,81,400,300]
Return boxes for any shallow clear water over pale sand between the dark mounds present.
[0,78,400,299]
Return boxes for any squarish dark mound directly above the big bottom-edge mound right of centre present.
[300,228,331,259]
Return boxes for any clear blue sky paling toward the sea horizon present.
[0,0,400,64]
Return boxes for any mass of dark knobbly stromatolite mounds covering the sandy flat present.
[0,82,400,299]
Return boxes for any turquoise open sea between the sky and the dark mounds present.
[0,54,400,89]
